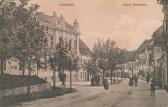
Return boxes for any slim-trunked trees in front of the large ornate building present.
[50,38,77,88]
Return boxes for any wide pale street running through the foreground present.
[15,81,158,107]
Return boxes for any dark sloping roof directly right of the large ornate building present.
[79,39,92,56]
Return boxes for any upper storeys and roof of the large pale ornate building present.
[36,12,80,56]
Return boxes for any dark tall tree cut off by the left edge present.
[0,0,16,74]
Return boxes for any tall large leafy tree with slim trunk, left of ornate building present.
[1,0,45,94]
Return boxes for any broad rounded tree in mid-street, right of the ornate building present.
[91,39,129,83]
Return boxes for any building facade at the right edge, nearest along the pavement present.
[152,26,168,88]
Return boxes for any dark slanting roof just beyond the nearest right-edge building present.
[136,39,152,54]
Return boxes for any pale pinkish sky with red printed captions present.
[30,0,163,50]
